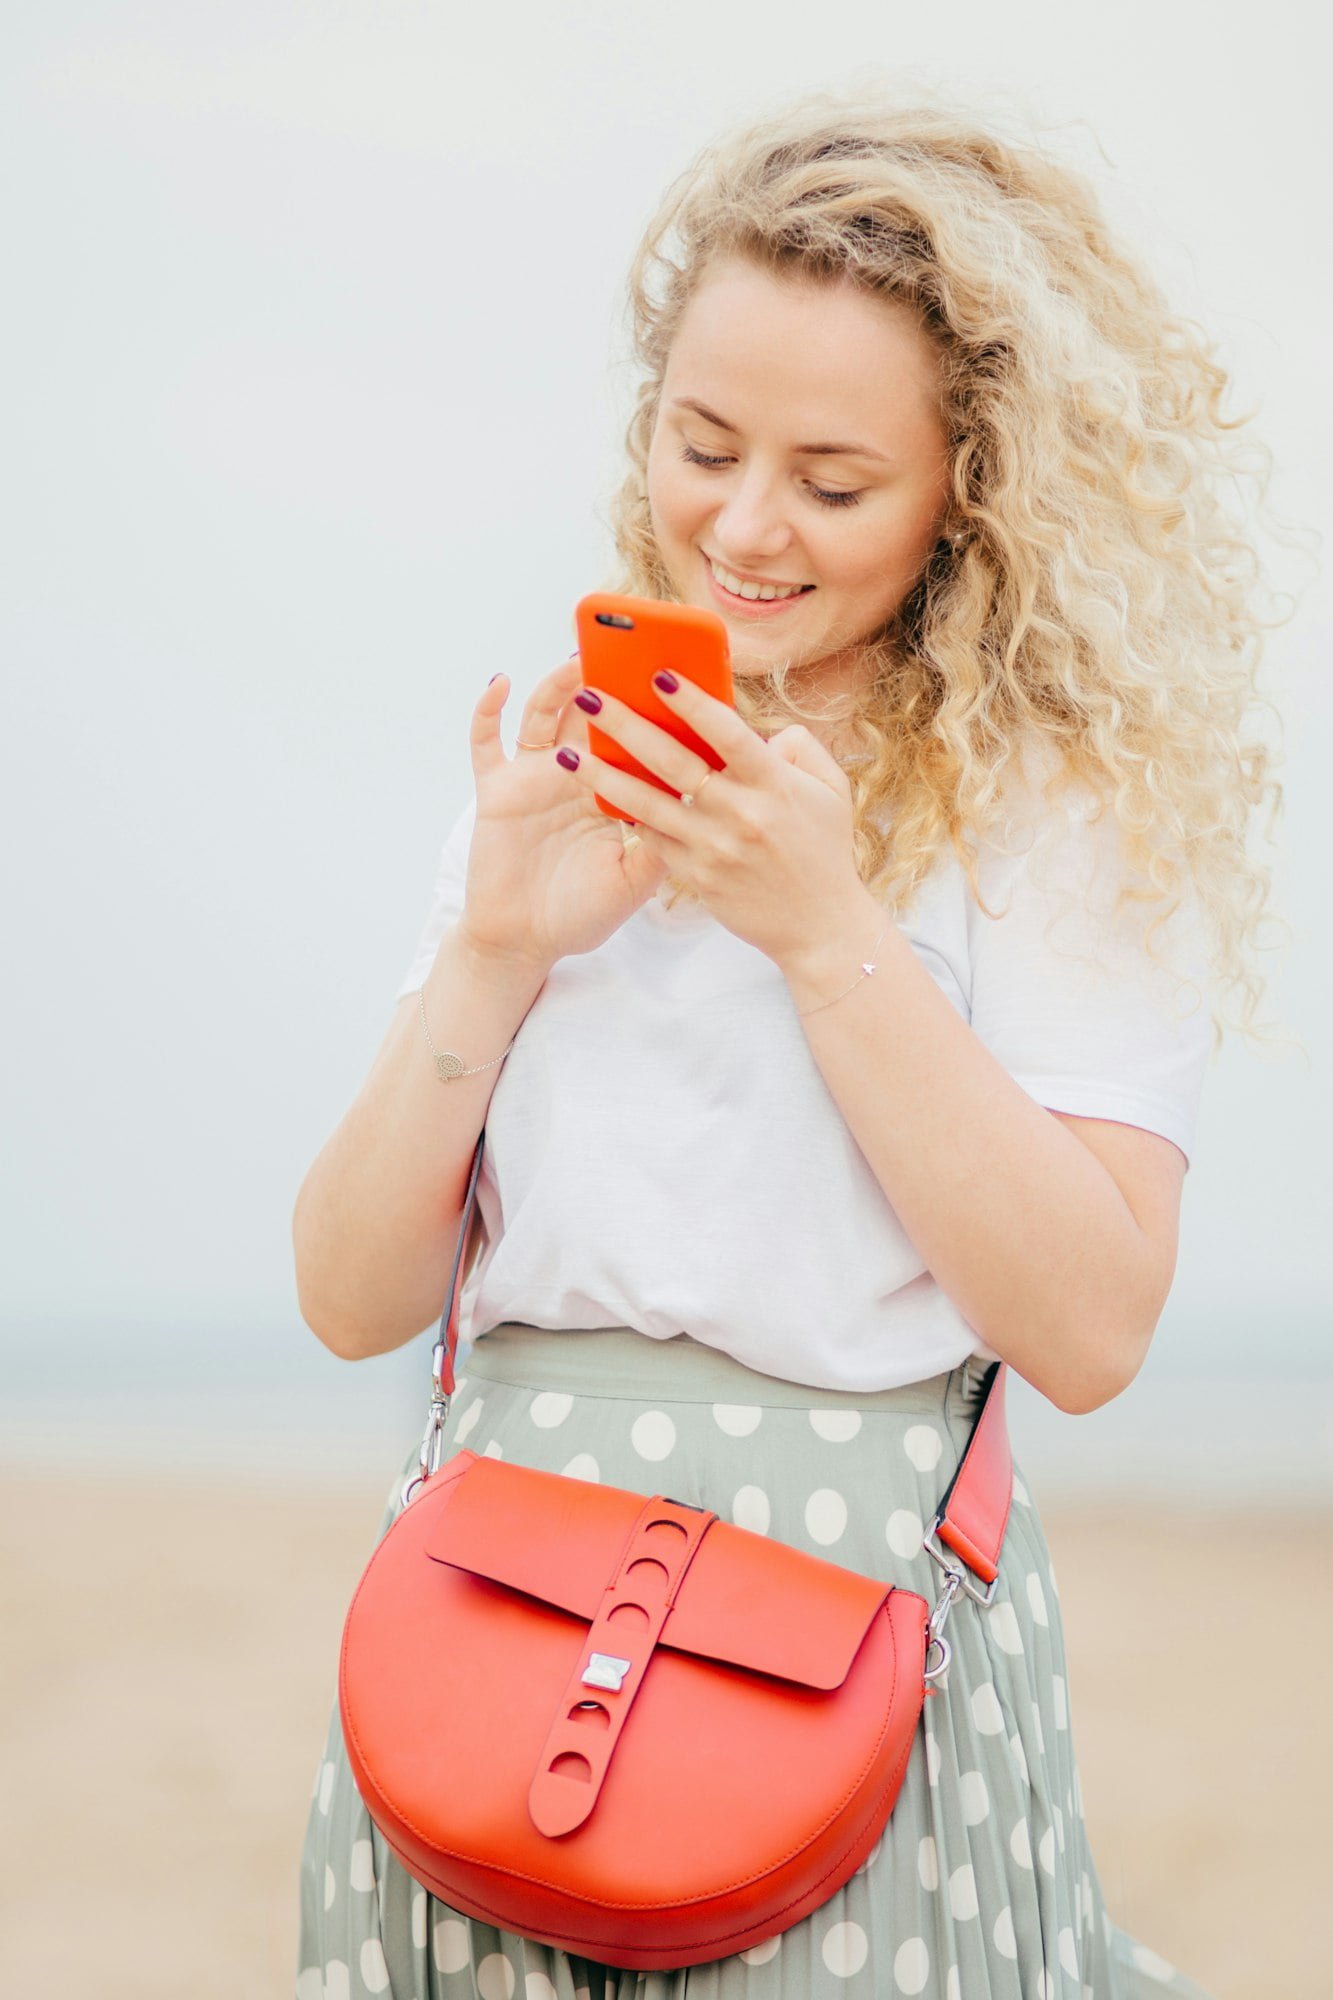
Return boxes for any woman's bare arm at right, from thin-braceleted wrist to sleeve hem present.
[779,886,1185,1412]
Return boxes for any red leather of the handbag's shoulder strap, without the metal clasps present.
[434,1126,1013,1584]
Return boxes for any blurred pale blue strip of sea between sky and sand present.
[0,1322,1333,1508]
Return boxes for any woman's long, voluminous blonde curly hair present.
[604,88,1289,1050]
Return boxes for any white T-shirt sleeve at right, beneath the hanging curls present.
[967,768,1213,1166]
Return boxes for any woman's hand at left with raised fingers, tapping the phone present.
[458,652,669,970]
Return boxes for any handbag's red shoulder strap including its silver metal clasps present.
[420,1126,1013,1624]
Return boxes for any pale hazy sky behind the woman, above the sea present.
[0,0,1333,1392]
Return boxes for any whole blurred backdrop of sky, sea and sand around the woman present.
[0,0,1333,2000]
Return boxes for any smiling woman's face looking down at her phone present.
[648,258,949,712]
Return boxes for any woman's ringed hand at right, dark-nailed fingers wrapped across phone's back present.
[556,674,865,964]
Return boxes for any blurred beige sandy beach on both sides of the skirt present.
[0,1468,1333,2000]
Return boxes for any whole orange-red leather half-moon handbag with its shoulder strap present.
[338,1132,1013,1970]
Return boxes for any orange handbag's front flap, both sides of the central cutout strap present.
[414,1452,893,1688]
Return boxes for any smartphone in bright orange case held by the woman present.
[574,590,737,826]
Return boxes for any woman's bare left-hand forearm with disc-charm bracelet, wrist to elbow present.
[292,926,546,1360]
